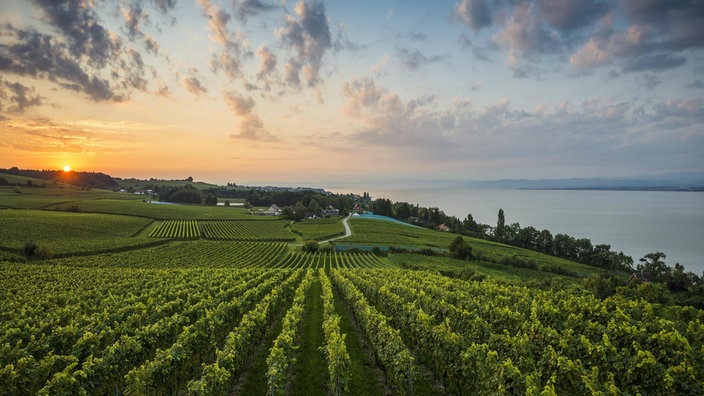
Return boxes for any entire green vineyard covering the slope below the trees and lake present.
[0,185,704,395]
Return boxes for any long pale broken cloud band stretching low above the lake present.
[342,79,704,169]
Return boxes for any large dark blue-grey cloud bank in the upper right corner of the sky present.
[451,0,704,77]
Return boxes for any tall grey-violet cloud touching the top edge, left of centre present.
[277,0,332,88]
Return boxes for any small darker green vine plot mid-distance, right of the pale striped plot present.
[198,220,296,242]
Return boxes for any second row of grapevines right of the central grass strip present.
[331,269,415,395]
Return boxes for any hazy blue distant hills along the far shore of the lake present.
[467,172,704,191]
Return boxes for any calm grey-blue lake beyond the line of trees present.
[332,187,704,275]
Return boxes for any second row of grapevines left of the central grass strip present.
[188,270,303,395]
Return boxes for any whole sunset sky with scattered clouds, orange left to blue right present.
[0,0,704,186]
